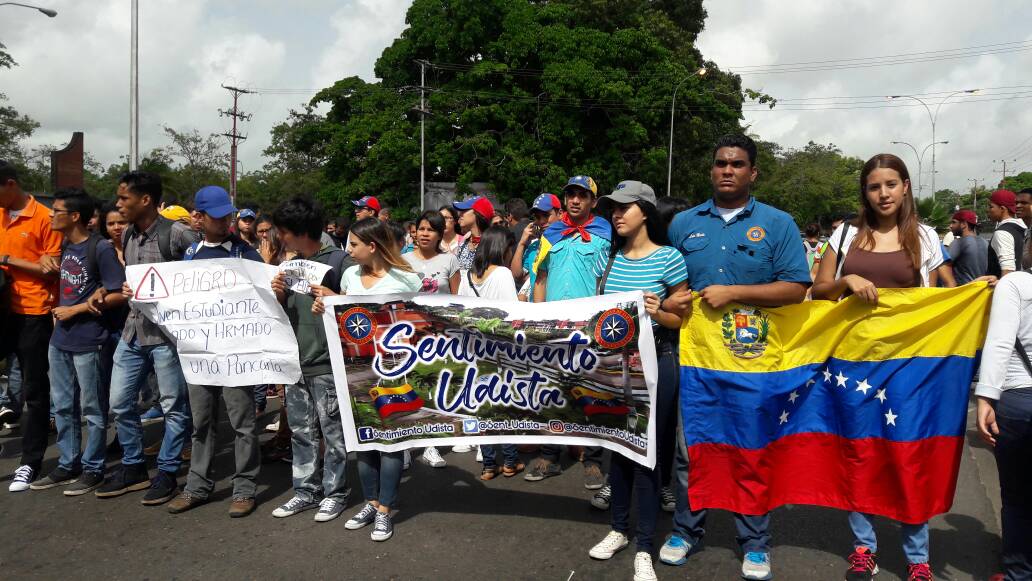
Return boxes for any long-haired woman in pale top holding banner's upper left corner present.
[312,218,423,541]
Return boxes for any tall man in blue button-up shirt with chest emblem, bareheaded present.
[659,135,810,579]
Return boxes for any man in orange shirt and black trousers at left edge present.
[0,160,61,492]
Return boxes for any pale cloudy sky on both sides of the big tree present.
[0,0,1032,193]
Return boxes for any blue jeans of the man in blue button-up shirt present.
[671,402,771,553]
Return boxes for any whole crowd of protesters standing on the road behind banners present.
[0,135,1032,581]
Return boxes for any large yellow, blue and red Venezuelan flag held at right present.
[680,284,991,523]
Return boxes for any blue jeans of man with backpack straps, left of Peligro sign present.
[110,338,191,473]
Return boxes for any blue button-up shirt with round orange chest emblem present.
[669,197,811,291]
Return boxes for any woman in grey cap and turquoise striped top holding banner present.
[588,182,687,581]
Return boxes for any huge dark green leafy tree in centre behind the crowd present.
[302,0,755,211]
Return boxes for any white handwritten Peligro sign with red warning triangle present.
[126,258,301,386]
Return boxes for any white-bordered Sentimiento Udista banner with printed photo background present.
[324,292,656,467]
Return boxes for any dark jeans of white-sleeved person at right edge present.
[996,388,1032,581]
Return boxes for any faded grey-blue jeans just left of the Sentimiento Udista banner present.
[284,374,351,502]
